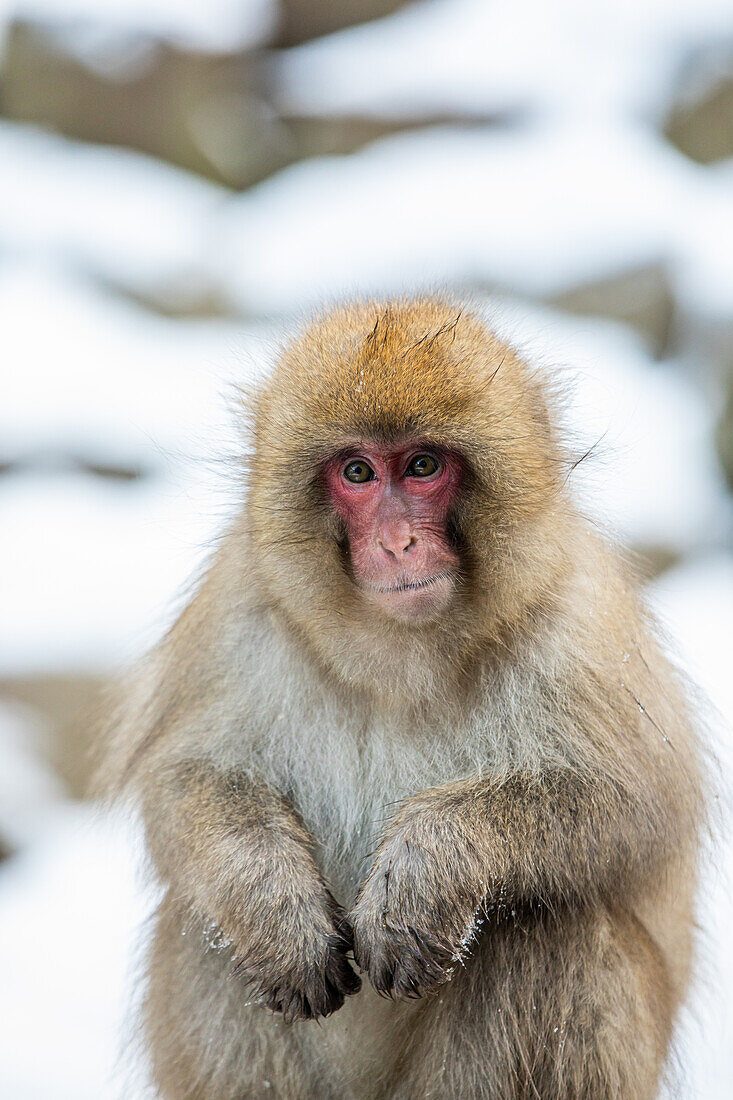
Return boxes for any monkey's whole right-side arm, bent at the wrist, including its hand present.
[351,749,689,997]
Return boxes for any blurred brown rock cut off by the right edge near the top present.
[665,43,733,164]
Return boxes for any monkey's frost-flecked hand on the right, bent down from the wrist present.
[351,794,486,998]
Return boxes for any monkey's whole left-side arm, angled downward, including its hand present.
[138,760,360,1020]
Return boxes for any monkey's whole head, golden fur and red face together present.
[247,299,569,677]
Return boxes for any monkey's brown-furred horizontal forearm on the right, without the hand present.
[392,770,686,904]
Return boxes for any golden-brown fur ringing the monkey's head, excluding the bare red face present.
[250,299,572,691]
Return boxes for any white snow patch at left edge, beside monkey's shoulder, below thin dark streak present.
[0,474,225,675]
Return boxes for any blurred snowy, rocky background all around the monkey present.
[0,0,733,1100]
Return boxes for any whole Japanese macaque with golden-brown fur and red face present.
[102,300,703,1100]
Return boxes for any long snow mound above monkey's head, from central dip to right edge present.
[215,123,733,314]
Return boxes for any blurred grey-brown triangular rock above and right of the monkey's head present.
[551,264,675,359]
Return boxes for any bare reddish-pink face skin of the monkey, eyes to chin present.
[325,444,461,619]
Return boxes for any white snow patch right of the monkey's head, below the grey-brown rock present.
[484,301,733,553]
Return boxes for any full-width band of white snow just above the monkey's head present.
[5,115,733,327]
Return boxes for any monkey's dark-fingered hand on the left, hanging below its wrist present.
[225,883,361,1023]
